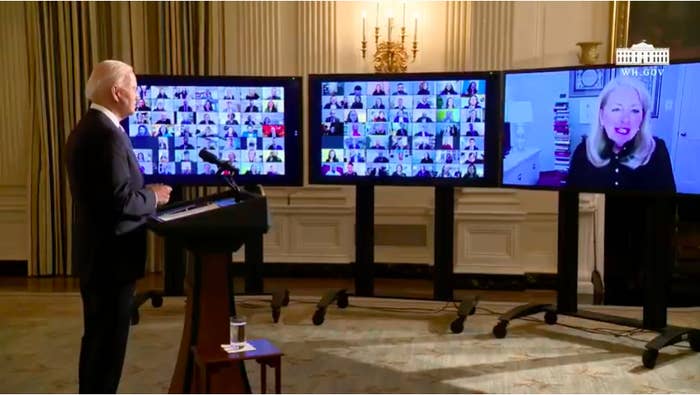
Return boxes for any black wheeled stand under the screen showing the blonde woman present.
[493,191,700,369]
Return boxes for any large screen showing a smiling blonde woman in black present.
[502,62,700,194]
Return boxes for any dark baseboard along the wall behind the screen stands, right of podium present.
[233,262,556,290]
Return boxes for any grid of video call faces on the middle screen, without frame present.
[320,80,486,178]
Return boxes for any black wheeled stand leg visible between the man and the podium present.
[131,186,185,325]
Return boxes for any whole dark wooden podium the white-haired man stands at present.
[148,186,270,393]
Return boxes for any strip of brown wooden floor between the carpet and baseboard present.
[0,273,556,303]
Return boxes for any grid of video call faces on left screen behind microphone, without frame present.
[128,85,285,175]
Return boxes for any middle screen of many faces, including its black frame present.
[309,73,499,186]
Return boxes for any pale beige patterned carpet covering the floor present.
[0,292,700,393]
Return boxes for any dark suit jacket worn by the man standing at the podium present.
[65,109,156,283]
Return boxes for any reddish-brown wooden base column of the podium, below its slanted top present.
[168,252,251,394]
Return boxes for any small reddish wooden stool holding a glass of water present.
[192,339,284,394]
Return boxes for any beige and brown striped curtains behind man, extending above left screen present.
[25,2,220,276]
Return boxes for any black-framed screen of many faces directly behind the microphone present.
[124,75,303,185]
